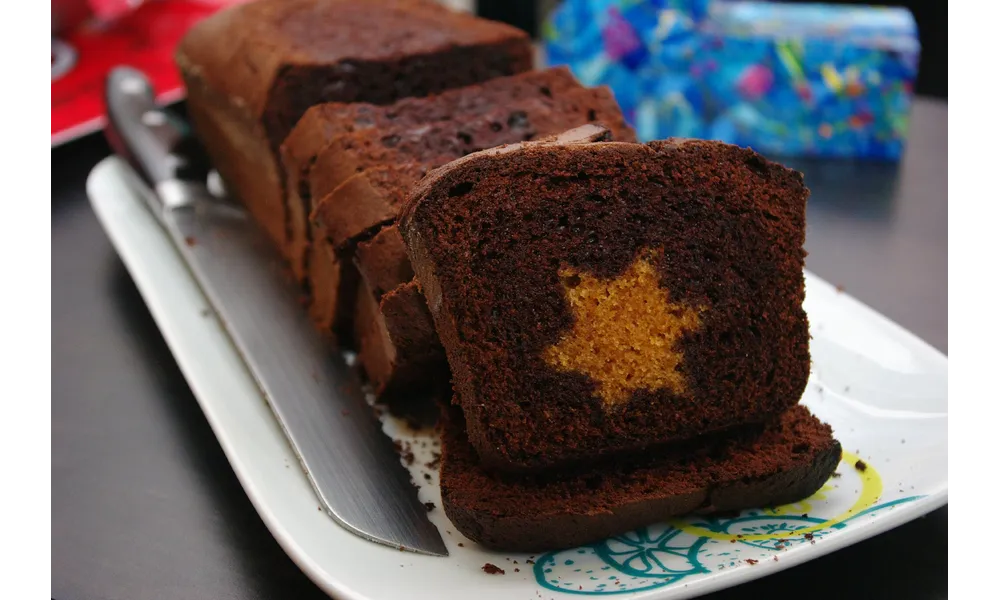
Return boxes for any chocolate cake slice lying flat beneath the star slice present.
[441,405,841,552]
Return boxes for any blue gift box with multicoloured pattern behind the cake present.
[545,0,920,160]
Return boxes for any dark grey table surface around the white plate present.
[48,101,952,600]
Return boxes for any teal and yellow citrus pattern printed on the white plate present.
[534,451,924,595]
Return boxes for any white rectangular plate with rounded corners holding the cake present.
[87,157,952,600]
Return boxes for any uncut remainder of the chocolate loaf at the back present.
[176,0,533,248]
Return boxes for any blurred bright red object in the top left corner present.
[49,0,247,146]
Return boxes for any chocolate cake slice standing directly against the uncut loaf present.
[281,67,582,279]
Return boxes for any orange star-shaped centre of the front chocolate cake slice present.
[542,251,705,407]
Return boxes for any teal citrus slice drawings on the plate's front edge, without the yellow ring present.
[534,496,923,596]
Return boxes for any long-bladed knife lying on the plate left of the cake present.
[105,67,448,556]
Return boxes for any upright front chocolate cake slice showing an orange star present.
[399,128,810,470]
